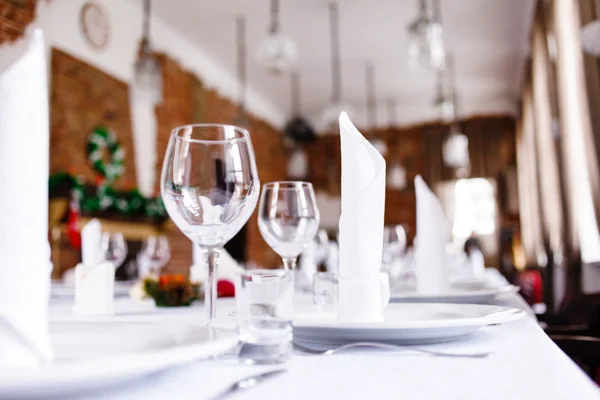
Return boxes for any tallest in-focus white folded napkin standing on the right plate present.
[338,113,390,321]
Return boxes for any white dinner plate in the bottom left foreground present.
[0,316,238,399]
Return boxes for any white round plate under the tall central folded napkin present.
[294,303,525,345]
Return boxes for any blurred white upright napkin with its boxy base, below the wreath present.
[73,219,115,315]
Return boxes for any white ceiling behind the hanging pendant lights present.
[153,0,534,125]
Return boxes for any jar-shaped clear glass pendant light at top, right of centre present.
[407,0,446,70]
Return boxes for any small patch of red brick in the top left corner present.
[0,0,37,45]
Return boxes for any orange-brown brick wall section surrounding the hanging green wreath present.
[50,49,136,189]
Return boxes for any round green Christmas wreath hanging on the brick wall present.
[86,127,125,182]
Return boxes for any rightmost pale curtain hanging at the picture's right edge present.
[551,0,600,266]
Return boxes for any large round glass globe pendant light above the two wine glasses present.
[257,0,298,75]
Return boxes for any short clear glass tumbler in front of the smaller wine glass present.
[235,269,294,364]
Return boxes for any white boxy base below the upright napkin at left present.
[73,262,115,315]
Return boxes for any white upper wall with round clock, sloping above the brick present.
[19,0,285,126]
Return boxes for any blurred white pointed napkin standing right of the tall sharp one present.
[415,176,448,294]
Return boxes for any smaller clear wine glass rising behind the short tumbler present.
[258,181,320,270]
